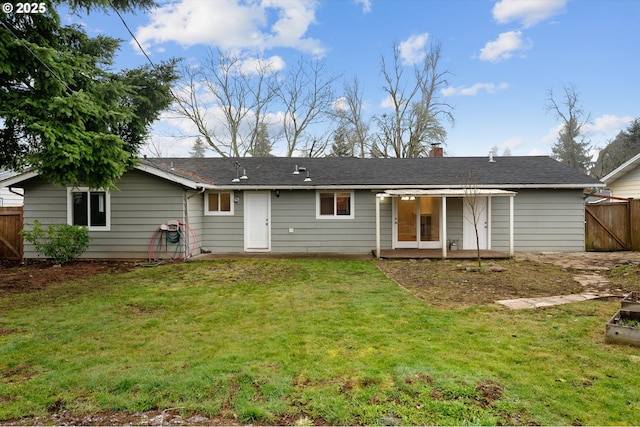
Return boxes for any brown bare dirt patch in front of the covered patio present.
[377,253,640,309]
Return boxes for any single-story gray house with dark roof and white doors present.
[0,156,603,258]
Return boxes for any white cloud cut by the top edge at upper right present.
[493,0,568,28]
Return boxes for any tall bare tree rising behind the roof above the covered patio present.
[372,43,453,157]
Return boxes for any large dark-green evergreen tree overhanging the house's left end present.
[0,0,177,188]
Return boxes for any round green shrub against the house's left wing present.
[20,219,90,264]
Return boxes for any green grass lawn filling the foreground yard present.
[0,260,640,425]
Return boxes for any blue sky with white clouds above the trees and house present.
[65,0,640,156]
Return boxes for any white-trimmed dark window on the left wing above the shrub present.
[67,187,111,231]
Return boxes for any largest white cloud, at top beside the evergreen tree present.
[136,0,324,56]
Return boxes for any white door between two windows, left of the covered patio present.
[244,191,271,252]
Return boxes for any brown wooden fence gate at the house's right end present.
[585,199,640,252]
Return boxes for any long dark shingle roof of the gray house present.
[142,156,602,188]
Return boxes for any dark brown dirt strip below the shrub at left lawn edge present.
[0,259,137,296]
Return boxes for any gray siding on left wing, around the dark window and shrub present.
[24,171,185,259]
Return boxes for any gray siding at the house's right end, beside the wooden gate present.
[491,190,584,252]
